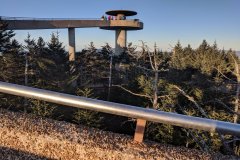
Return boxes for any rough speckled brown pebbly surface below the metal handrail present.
[0,109,238,160]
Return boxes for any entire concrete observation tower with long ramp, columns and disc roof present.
[0,10,143,61]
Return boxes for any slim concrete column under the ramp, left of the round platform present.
[68,28,76,61]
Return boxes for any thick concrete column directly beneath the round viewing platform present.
[115,29,127,55]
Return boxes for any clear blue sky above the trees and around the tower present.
[0,0,240,50]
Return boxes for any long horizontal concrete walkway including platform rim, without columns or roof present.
[0,18,143,30]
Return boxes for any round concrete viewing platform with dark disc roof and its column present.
[100,10,143,55]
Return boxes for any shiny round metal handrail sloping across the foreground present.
[0,82,240,136]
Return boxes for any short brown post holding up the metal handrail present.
[134,119,146,142]
